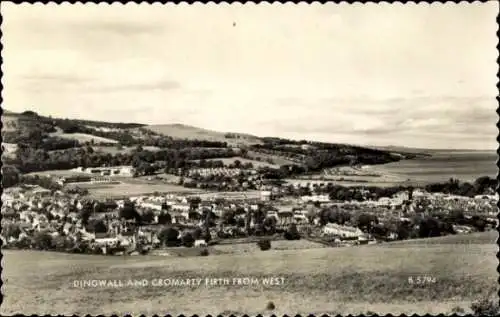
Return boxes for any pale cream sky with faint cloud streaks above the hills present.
[0,2,498,149]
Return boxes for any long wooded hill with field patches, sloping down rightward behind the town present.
[3,111,422,177]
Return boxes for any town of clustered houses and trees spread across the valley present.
[2,160,498,255]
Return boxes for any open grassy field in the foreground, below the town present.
[1,232,498,315]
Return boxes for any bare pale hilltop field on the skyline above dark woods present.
[147,124,262,144]
